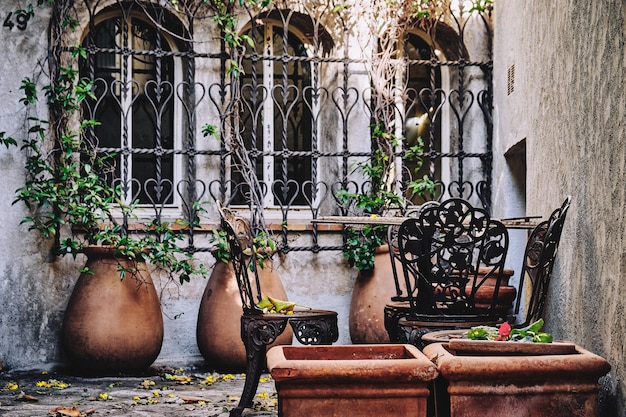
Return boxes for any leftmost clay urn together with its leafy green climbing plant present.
[0,57,207,373]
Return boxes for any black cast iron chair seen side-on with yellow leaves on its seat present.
[219,206,339,417]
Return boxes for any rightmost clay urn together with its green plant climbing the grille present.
[339,124,436,343]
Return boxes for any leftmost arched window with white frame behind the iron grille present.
[81,11,181,207]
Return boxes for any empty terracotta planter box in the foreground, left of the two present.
[267,344,438,417]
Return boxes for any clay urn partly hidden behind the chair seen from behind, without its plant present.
[349,245,402,343]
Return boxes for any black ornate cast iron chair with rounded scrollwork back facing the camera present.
[389,198,509,348]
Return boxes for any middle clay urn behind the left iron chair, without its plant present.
[196,260,293,372]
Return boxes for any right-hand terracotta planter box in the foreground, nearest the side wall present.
[424,341,611,417]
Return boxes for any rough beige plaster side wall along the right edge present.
[494,0,626,416]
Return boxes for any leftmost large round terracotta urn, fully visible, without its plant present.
[62,247,163,374]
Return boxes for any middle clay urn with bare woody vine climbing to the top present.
[190,0,293,372]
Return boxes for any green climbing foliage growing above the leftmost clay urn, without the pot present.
[0,49,208,283]
